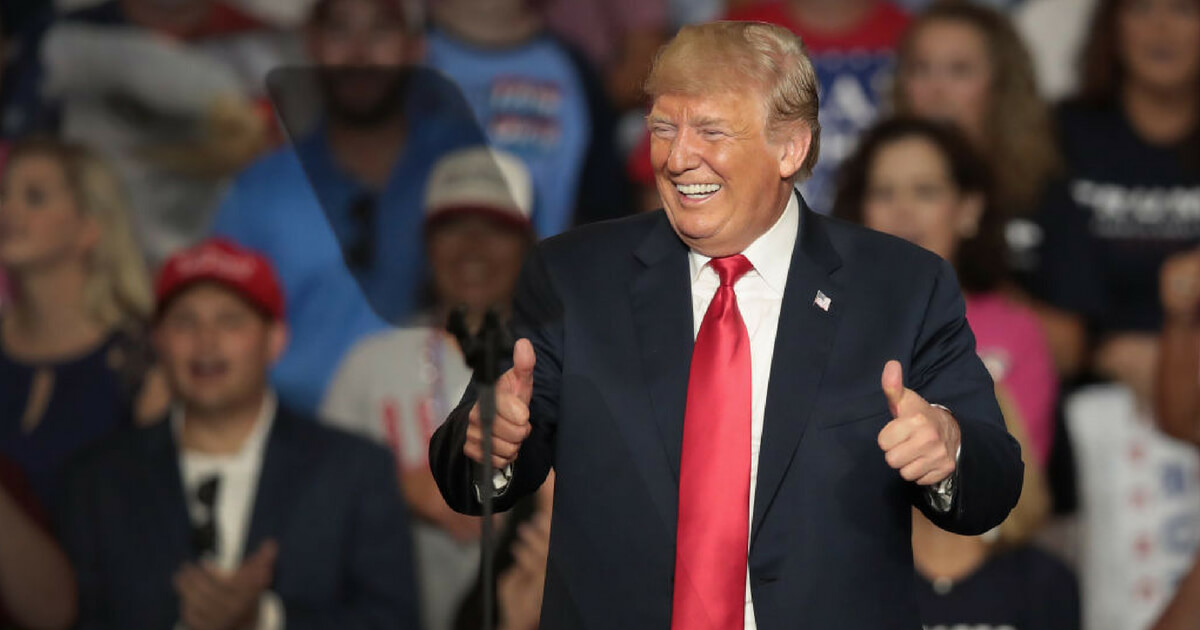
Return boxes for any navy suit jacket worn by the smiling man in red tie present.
[430,204,1022,630]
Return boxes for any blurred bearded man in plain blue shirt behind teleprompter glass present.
[214,0,482,413]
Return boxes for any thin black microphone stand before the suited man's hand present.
[446,307,514,630]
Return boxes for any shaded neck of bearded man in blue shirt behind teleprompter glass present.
[329,116,406,191]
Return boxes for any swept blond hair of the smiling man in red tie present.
[646,22,821,180]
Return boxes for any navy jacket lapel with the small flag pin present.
[750,199,845,545]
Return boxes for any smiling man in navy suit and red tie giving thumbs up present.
[430,22,1022,630]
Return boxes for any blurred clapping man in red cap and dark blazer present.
[60,239,418,630]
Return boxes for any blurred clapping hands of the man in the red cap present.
[175,540,278,630]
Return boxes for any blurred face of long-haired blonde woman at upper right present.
[899,19,992,139]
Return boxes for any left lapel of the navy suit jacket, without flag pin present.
[630,214,695,494]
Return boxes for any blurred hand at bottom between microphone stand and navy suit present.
[496,510,550,630]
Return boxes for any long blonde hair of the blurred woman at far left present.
[5,138,154,329]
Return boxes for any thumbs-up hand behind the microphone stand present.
[462,340,538,468]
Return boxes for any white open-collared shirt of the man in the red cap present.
[170,391,284,630]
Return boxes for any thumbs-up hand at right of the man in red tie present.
[878,361,961,486]
